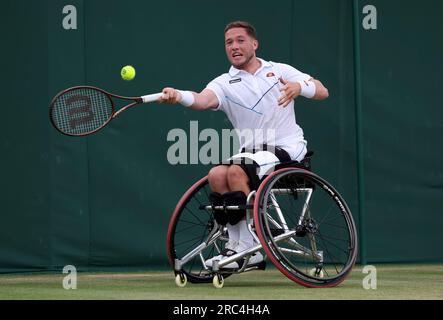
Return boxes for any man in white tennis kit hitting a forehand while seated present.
[159,21,329,269]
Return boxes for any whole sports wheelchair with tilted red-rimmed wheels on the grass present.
[167,152,357,288]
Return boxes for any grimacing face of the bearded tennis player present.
[225,28,258,69]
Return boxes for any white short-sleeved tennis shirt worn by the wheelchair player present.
[206,59,311,160]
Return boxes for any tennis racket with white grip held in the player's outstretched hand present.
[49,86,163,136]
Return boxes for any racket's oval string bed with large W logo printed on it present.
[51,88,114,135]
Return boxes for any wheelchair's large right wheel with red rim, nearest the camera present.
[254,168,357,288]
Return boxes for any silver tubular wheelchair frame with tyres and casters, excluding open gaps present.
[168,161,357,288]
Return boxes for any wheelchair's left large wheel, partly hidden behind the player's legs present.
[167,177,228,283]
